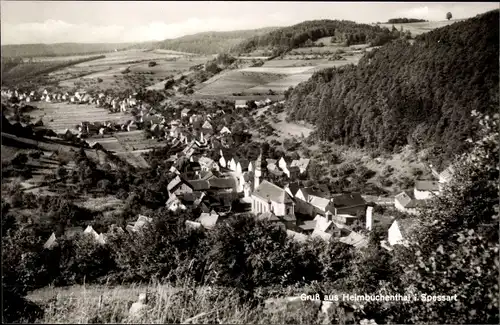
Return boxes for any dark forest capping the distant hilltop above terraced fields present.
[233,19,394,53]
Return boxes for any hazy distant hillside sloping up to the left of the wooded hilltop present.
[141,27,278,54]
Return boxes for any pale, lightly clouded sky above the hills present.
[0,0,499,45]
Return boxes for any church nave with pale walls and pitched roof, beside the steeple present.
[252,180,295,216]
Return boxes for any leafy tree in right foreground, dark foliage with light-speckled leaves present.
[362,112,500,324]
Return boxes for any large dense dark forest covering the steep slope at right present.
[286,10,499,167]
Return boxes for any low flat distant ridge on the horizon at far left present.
[2,43,135,58]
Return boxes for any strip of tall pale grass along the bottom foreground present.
[28,283,324,324]
